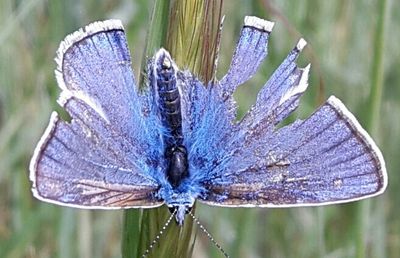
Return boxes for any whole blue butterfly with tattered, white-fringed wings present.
[30,16,387,224]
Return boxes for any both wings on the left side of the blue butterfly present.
[30,20,162,208]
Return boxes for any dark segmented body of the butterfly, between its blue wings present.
[155,49,188,188]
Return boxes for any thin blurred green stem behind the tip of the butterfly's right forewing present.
[356,0,389,258]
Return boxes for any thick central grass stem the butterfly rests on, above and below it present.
[122,0,222,258]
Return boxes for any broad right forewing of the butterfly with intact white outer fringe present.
[203,97,387,207]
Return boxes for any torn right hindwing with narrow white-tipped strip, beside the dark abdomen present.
[180,16,274,182]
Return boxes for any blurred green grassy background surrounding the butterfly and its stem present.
[0,0,400,258]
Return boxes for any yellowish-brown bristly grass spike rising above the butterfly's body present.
[167,0,223,80]
